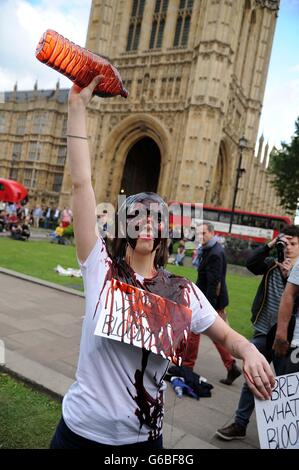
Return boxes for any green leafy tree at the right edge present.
[268,117,299,214]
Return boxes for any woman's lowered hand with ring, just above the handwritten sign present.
[243,344,275,400]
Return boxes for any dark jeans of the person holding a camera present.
[235,333,289,428]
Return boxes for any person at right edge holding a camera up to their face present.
[216,225,299,441]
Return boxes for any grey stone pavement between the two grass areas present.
[0,268,259,449]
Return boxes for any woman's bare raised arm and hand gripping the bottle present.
[67,77,101,262]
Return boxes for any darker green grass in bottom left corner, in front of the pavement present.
[0,372,61,449]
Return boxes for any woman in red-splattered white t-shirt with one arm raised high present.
[51,77,274,451]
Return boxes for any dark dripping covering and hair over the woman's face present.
[111,192,168,268]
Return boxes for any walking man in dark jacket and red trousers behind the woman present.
[183,223,241,385]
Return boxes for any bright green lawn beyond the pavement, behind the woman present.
[0,238,259,338]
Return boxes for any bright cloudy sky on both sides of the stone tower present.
[0,0,299,149]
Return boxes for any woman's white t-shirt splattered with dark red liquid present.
[63,239,217,446]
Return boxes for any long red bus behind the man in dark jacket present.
[168,201,293,243]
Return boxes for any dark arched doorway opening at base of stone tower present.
[120,137,161,196]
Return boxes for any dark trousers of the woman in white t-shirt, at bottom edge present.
[50,417,163,451]
